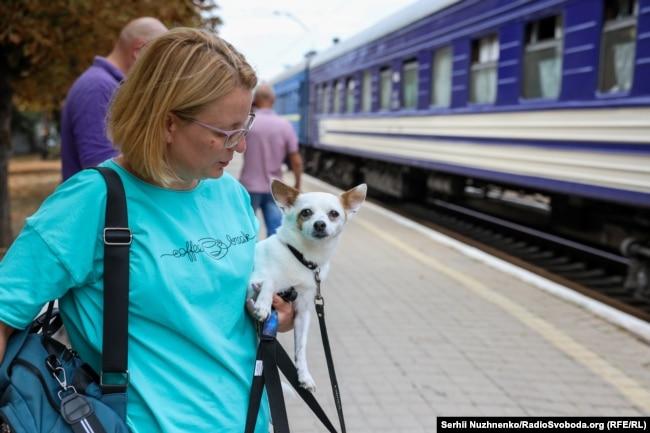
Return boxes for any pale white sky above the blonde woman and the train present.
[217,0,414,80]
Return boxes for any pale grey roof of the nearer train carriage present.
[310,0,461,67]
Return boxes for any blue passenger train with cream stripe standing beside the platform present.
[273,0,650,290]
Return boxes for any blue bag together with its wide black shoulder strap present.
[0,168,132,433]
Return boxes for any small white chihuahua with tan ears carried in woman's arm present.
[248,180,367,392]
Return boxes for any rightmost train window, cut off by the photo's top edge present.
[598,0,638,93]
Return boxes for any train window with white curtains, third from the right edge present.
[470,35,499,104]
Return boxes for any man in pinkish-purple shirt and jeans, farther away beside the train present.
[239,84,302,236]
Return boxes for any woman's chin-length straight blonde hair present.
[107,27,257,186]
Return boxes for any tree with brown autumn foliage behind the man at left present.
[0,0,221,247]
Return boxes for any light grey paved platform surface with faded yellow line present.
[232,154,650,433]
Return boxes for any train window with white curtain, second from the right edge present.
[522,15,562,99]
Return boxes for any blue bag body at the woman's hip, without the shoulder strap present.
[0,315,129,433]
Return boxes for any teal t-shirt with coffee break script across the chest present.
[0,161,269,433]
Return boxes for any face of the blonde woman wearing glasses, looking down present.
[166,88,253,189]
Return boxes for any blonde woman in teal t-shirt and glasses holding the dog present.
[0,28,291,433]
